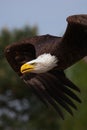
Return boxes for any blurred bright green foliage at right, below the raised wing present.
[60,60,87,130]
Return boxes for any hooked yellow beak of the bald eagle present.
[20,63,34,74]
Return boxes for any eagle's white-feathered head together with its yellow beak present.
[20,53,58,73]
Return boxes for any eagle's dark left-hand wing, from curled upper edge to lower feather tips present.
[5,43,81,119]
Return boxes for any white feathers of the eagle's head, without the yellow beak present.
[26,53,58,73]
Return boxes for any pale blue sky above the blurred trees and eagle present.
[0,0,87,36]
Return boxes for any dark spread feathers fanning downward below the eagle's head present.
[23,71,81,119]
